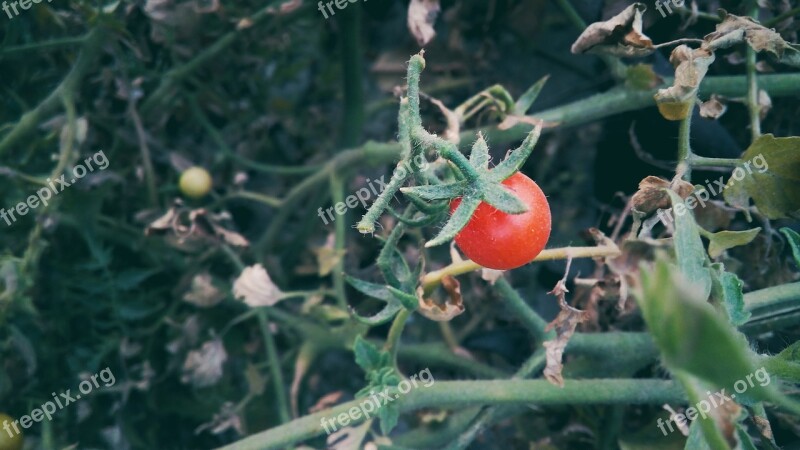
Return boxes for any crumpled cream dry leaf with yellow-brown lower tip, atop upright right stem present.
[655,45,714,120]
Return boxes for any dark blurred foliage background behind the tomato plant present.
[0,0,800,448]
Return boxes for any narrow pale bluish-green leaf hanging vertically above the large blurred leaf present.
[666,189,711,299]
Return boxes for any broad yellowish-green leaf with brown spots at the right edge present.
[723,134,800,219]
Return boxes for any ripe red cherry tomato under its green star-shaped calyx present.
[450,172,551,270]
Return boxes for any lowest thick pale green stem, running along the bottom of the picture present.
[217,379,686,450]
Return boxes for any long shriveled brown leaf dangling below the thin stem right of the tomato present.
[543,276,587,387]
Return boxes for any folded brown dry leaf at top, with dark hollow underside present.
[571,3,655,57]
